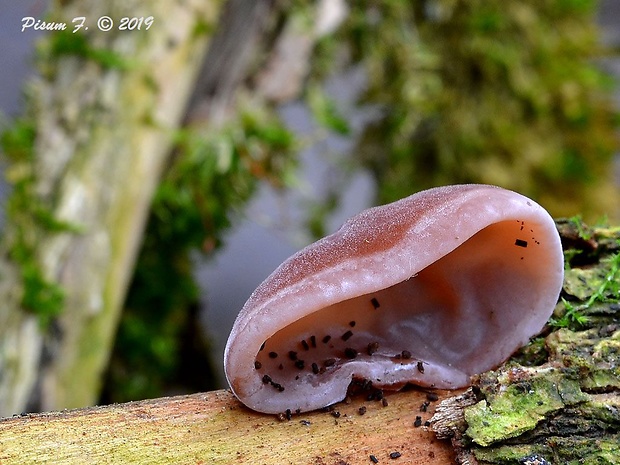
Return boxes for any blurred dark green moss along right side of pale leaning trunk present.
[104,107,296,402]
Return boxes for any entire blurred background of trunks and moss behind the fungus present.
[0,0,620,415]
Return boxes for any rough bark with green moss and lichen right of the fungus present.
[462,222,620,465]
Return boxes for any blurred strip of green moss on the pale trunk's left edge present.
[0,119,67,327]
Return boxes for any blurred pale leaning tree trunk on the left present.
[0,0,221,415]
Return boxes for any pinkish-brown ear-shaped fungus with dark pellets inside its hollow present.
[224,185,563,413]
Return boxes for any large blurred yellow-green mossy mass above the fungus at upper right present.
[318,0,618,217]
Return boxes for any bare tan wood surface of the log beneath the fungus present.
[0,390,454,465]
